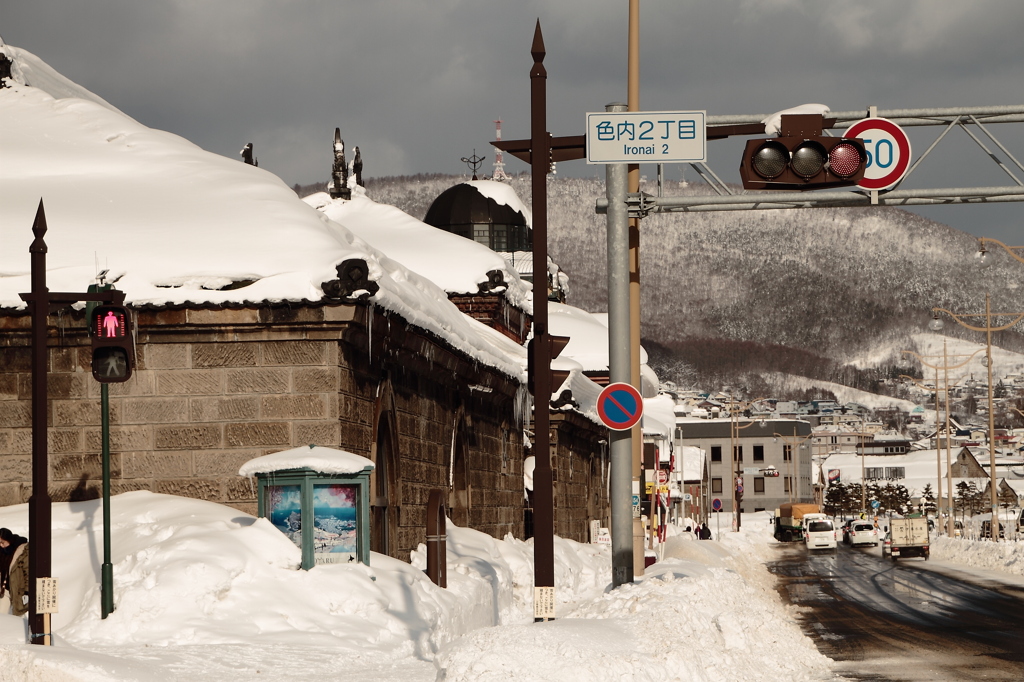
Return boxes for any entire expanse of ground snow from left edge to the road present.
[0,492,830,682]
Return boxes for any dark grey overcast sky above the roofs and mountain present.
[6,0,1024,244]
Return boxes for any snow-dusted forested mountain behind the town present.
[368,175,1024,390]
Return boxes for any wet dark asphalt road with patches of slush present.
[768,543,1024,682]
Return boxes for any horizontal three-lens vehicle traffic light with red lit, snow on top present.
[739,114,867,189]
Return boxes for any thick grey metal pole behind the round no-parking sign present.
[604,103,634,587]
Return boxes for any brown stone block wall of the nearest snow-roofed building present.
[0,304,522,559]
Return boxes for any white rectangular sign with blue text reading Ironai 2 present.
[587,112,708,164]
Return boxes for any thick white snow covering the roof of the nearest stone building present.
[0,46,522,376]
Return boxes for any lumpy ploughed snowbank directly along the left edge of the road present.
[437,514,831,682]
